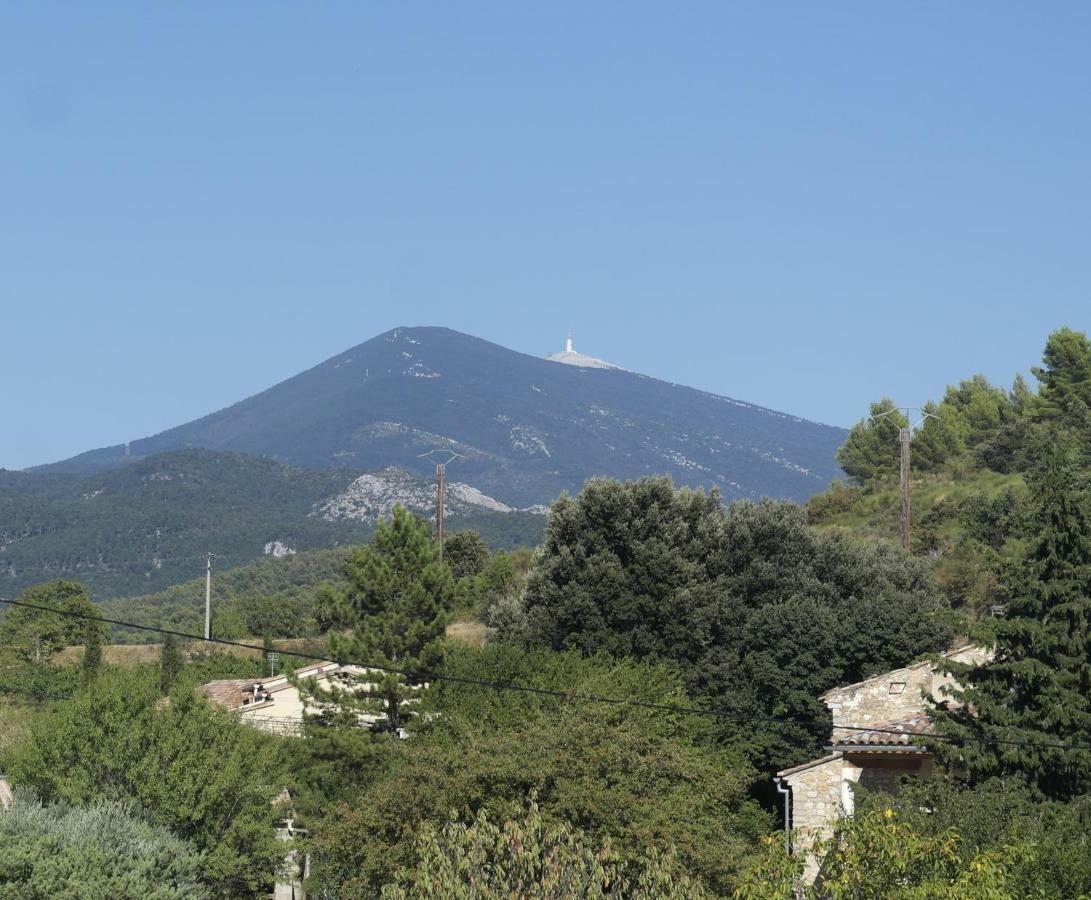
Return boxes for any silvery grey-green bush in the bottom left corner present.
[0,792,212,900]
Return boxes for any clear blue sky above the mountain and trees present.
[0,0,1091,468]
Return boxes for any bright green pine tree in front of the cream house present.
[301,506,455,732]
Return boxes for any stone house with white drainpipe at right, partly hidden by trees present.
[775,646,988,880]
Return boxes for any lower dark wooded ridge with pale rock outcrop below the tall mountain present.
[0,449,544,599]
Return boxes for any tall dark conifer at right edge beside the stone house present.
[936,449,1091,799]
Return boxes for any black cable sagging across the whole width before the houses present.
[0,597,1091,751]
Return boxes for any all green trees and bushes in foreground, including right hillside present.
[6,331,1091,900]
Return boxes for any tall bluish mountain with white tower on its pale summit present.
[43,327,846,507]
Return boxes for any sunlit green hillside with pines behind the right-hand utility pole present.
[806,328,1091,617]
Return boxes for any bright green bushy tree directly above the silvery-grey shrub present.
[8,670,286,889]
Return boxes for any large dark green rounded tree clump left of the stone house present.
[514,478,951,767]
